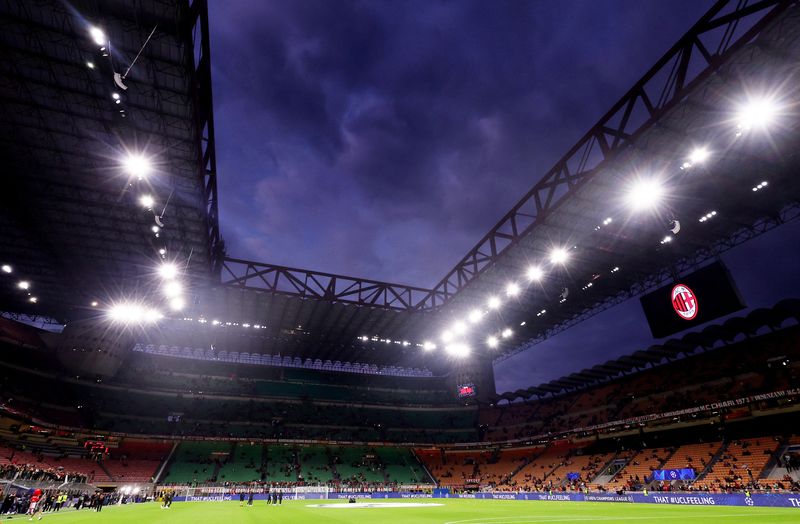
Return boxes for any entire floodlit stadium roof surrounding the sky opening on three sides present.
[0,0,800,370]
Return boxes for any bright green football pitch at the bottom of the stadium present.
[7,499,800,524]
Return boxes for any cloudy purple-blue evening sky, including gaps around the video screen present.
[209,0,800,392]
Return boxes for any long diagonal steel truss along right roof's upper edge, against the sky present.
[422,0,794,308]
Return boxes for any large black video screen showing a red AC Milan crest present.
[640,262,745,338]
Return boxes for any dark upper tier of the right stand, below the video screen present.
[479,328,800,441]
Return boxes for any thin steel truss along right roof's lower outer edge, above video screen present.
[494,202,800,363]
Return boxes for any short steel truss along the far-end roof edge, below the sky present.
[222,257,431,311]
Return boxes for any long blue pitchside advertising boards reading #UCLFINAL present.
[174,489,800,509]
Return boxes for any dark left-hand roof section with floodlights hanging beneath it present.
[0,0,219,321]
